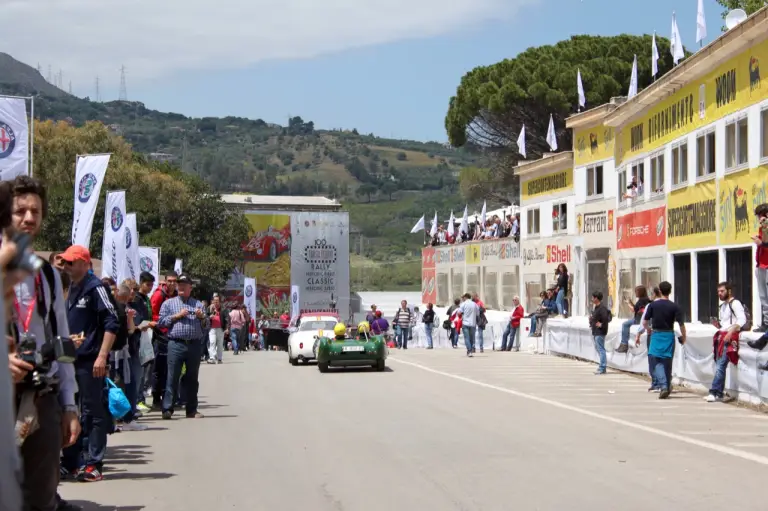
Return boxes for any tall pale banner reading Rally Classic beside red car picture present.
[289,212,350,319]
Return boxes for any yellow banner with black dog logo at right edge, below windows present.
[717,167,768,245]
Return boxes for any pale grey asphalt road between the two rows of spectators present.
[61,350,768,511]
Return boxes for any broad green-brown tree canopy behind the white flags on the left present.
[34,121,249,293]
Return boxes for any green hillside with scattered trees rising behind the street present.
[0,53,481,288]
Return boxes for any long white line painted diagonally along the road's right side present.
[391,357,768,466]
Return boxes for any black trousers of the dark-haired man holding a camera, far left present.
[17,388,62,511]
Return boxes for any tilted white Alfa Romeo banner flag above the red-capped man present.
[72,154,109,248]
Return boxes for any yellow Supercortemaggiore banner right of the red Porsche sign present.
[667,181,717,251]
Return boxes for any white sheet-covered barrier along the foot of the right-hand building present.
[543,317,768,404]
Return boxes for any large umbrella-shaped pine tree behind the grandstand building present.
[445,34,672,204]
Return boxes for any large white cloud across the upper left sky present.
[0,0,536,85]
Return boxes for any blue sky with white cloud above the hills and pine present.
[0,0,722,142]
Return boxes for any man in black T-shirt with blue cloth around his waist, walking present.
[643,281,686,399]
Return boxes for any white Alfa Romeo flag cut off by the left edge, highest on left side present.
[0,96,29,181]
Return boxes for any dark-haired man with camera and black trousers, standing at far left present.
[6,176,80,510]
